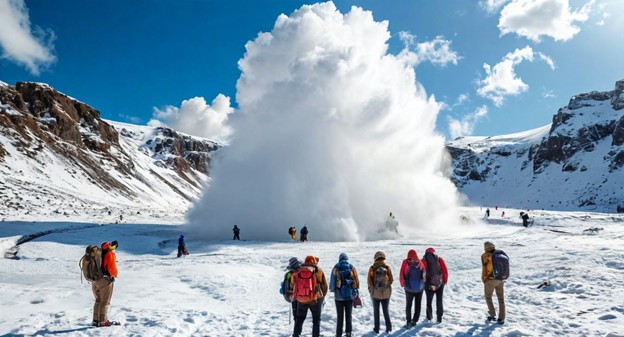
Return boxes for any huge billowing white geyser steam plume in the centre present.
[188,2,458,241]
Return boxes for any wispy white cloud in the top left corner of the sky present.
[0,0,56,75]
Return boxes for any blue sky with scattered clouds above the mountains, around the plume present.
[0,0,624,139]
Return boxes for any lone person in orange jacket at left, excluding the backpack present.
[91,241,119,326]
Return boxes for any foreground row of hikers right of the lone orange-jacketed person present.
[281,241,506,337]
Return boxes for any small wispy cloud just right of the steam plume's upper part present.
[399,32,461,67]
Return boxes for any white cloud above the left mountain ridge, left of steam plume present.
[148,94,234,142]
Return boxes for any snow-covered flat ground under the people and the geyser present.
[0,208,624,337]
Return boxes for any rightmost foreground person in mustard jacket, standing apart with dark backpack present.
[481,241,507,324]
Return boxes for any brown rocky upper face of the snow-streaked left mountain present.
[0,82,219,210]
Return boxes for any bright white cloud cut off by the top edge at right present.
[498,0,595,42]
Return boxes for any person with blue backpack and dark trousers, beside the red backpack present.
[329,253,360,337]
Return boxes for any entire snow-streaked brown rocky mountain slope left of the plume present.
[0,82,219,219]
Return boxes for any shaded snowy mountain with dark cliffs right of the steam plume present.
[447,80,624,212]
